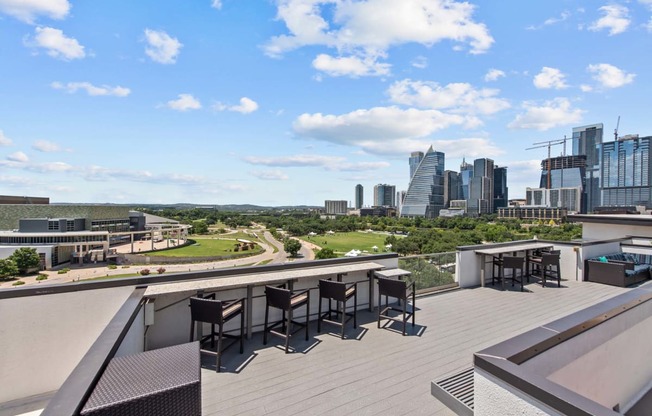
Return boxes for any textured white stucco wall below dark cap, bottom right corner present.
[473,367,561,416]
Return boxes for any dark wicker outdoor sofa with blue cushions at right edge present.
[584,253,652,287]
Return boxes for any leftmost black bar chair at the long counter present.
[190,293,245,372]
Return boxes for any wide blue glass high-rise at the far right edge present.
[600,135,652,209]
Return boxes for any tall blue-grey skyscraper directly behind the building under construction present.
[573,123,604,213]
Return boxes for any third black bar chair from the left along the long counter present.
[317,279,358,339]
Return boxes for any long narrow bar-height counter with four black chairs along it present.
[145,262,385,339]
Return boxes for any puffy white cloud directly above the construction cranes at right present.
[507,98,584,131]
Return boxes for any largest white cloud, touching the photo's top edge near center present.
[263,0,494,76]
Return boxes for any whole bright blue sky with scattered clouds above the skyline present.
[0,0,652,206]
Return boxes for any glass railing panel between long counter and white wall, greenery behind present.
[398,251,455,292]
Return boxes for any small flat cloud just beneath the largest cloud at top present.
[312,53,391,78]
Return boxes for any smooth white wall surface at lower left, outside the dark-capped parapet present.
[0,286,133,403]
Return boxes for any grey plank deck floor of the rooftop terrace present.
[202,281,628,415]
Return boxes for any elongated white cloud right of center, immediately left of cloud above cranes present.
[387,79,510,115]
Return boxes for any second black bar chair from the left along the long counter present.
[263,286,310,354]
